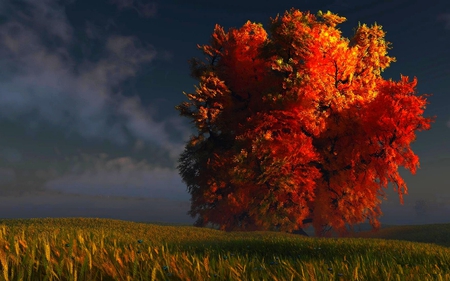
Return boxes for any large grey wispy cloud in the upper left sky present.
[0,0,185,155]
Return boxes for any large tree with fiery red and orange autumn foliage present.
[176,9,433,236]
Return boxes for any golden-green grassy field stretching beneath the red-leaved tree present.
[0,218,450,281]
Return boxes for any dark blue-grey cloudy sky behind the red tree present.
[0,0,450,230]
